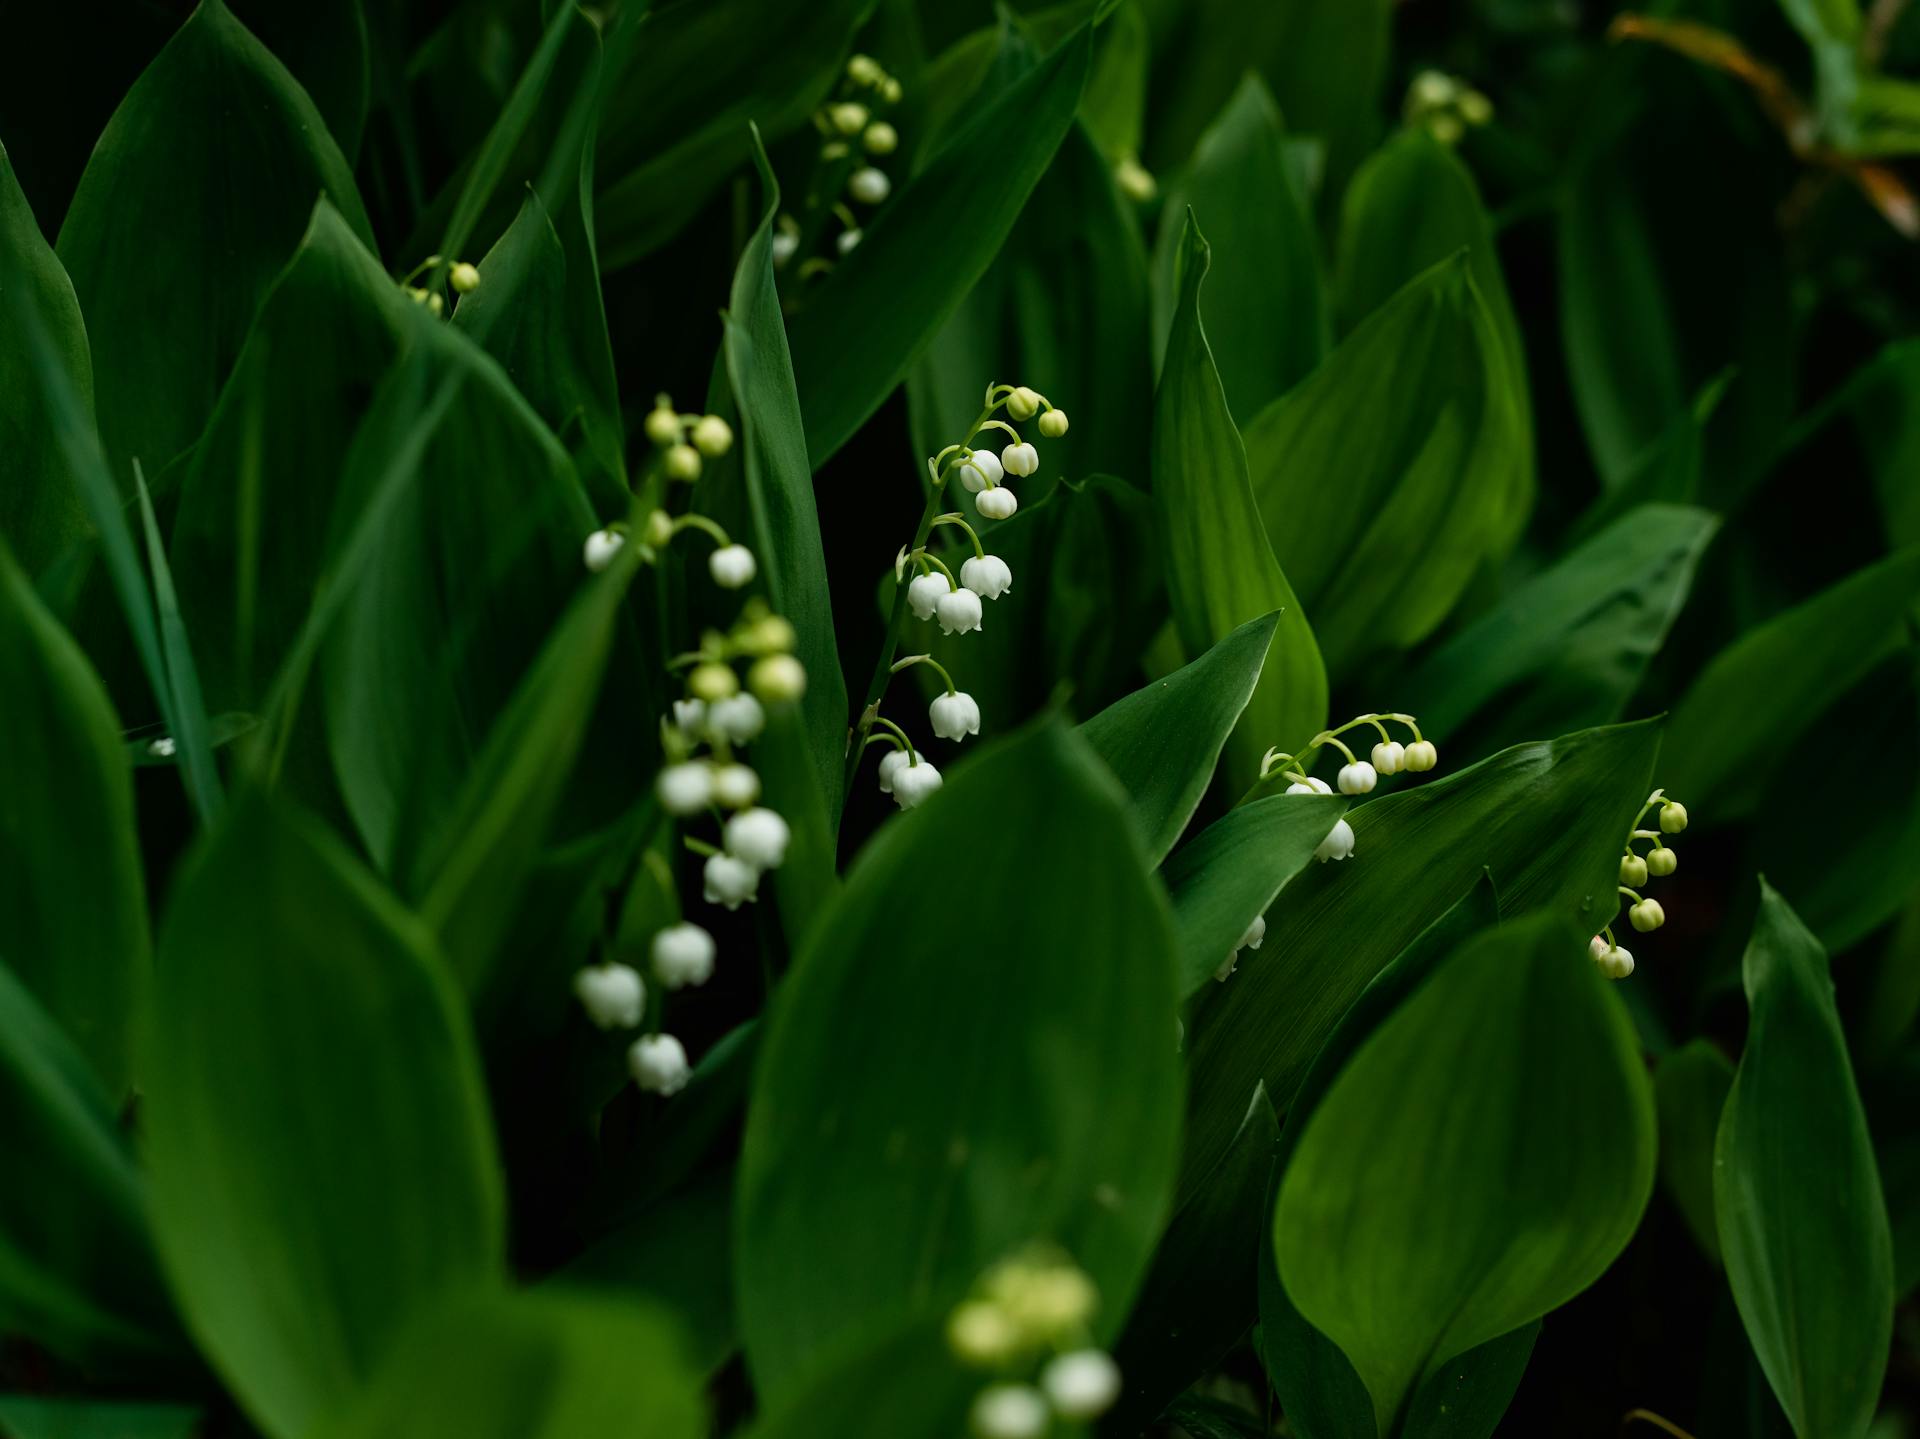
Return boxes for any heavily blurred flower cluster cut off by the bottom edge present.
[947,1251,1119,1439]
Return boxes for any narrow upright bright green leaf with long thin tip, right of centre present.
[1154,213,1327,787]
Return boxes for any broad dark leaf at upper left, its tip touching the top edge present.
[58,0,372,482]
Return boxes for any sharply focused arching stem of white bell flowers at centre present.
[847,384,1068,809]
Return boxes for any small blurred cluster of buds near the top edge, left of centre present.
[774,56,900,280]
